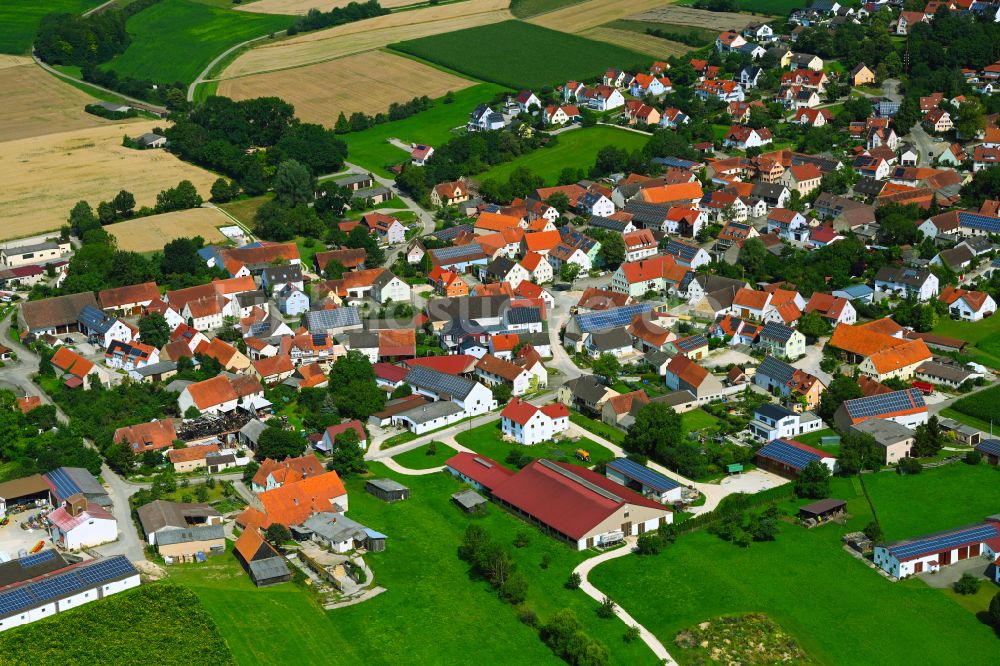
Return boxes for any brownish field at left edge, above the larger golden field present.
[0,56,137,141]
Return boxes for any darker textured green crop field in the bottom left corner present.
[0,583,234,666]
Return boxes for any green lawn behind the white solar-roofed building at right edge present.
[865,463,1000,539]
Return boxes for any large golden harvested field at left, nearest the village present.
[0,121,216,240]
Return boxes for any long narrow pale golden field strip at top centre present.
[219,0,512,79]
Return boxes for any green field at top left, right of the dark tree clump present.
[104,0,292,83]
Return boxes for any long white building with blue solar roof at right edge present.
[873,512,1000,579]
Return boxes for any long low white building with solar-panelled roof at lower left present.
[0,549,140,631]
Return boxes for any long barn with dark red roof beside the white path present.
[447,454,673,550]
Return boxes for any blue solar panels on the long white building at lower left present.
[0,551,138,617]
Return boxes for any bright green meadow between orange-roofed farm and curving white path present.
[170,464,655,666]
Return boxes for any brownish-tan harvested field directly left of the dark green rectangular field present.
[219,51,474,127]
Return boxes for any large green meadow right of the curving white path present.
[590,465,997,665]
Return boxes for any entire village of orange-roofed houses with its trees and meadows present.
[0,0,1000,665]
